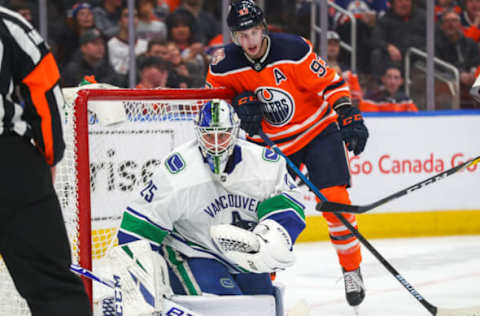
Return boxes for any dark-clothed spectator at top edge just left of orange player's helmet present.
[175,0,221,45]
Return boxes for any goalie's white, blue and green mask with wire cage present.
[194,99,240,175]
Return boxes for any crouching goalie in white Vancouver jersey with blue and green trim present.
[100,99,305,315]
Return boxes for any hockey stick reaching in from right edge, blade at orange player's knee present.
[316,156,480,214]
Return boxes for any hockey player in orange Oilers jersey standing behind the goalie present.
[207,0,368,306]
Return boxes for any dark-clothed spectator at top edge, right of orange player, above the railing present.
[371,0,426,76]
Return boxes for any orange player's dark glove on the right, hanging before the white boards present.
[336,105,368,155]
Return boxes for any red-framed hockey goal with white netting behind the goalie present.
[0,85,233,316]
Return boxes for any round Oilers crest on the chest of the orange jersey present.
[256,87,295,126]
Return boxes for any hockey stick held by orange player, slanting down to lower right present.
[259,130,480,316]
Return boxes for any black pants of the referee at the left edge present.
[0,136,91,316]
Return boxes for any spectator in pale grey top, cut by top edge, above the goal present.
[136,0,167,41]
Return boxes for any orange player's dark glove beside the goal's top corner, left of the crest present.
[232,91,263,136]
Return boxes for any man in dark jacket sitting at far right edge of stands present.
[435,9,480,108]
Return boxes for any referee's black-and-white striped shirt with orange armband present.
[0,6,65,166]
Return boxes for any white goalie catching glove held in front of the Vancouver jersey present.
[210,219,295,273]
